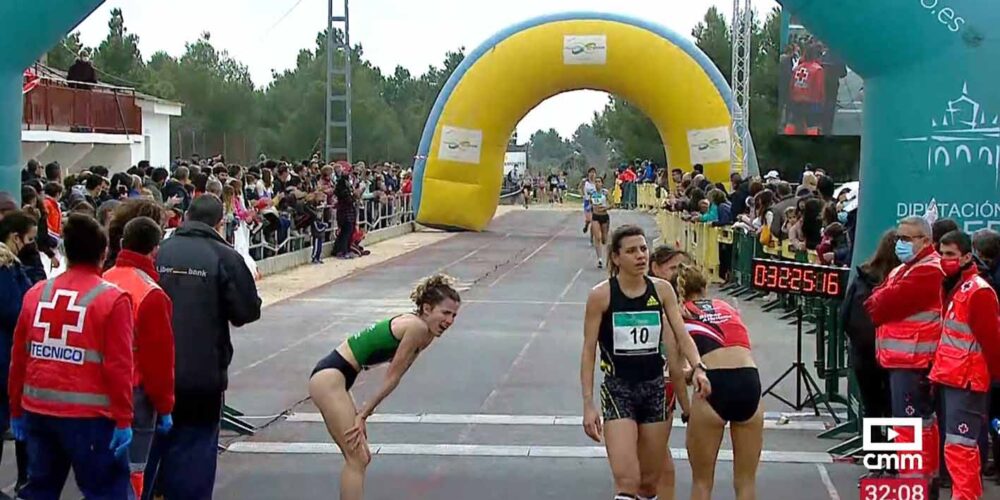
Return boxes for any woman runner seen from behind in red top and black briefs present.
[677,265,764,500]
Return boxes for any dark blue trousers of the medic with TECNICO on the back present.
[20,413,131,500]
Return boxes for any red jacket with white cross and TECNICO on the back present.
[7,266,133,428]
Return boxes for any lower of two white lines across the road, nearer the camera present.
[226,441,833,465]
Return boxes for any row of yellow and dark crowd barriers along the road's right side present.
[639,210,864,456]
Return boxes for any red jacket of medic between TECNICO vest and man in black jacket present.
[104,250,174,415]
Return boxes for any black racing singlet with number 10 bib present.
[598,276,666,381]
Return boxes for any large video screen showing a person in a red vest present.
[778,15,864,136]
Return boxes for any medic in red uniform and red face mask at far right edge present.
[930,231,1000,500]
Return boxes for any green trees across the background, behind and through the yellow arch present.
[48,7,859,178]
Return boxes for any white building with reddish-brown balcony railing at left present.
[21,70,183,174]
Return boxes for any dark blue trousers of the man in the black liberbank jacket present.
[142,423,219,500]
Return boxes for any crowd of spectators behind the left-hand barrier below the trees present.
[19,154,412,276]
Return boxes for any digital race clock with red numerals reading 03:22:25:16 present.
[753,259,850,299]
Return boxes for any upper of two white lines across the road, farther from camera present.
[286,413,827,432]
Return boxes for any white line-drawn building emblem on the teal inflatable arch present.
[899,83,1000,187]
